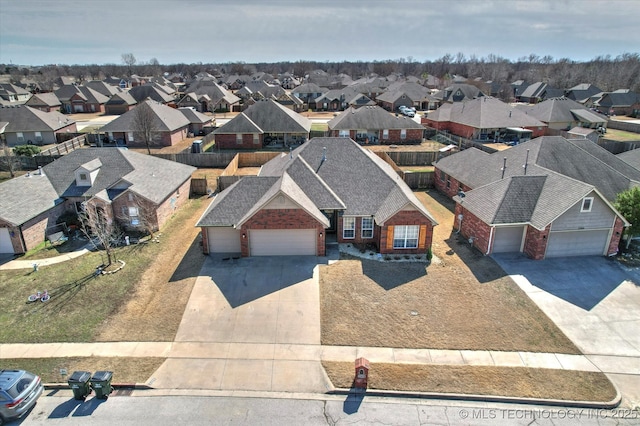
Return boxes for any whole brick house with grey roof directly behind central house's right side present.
[328,106,424,144]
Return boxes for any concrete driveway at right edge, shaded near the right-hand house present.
[492,253,640,407]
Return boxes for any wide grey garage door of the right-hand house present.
[545,229,609,257]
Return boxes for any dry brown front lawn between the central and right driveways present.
[320,193,580,354]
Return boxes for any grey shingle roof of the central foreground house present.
[197,138,436,226]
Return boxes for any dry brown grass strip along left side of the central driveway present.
[95,198,209,342]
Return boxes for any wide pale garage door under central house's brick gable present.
[249,229,316,256]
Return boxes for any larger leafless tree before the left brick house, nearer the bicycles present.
[78,200,122,266]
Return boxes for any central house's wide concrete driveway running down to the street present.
[148,255,338,393]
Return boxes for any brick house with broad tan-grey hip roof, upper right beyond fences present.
[421,96,547,142]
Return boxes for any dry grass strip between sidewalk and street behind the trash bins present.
[2,357,165,383]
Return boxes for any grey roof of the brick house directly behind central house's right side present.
[327,106,424,130]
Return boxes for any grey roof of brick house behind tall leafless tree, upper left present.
[100,100,189,132]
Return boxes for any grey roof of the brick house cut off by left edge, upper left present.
[0,105,75,133]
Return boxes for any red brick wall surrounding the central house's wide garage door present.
[239,209,325,257]
